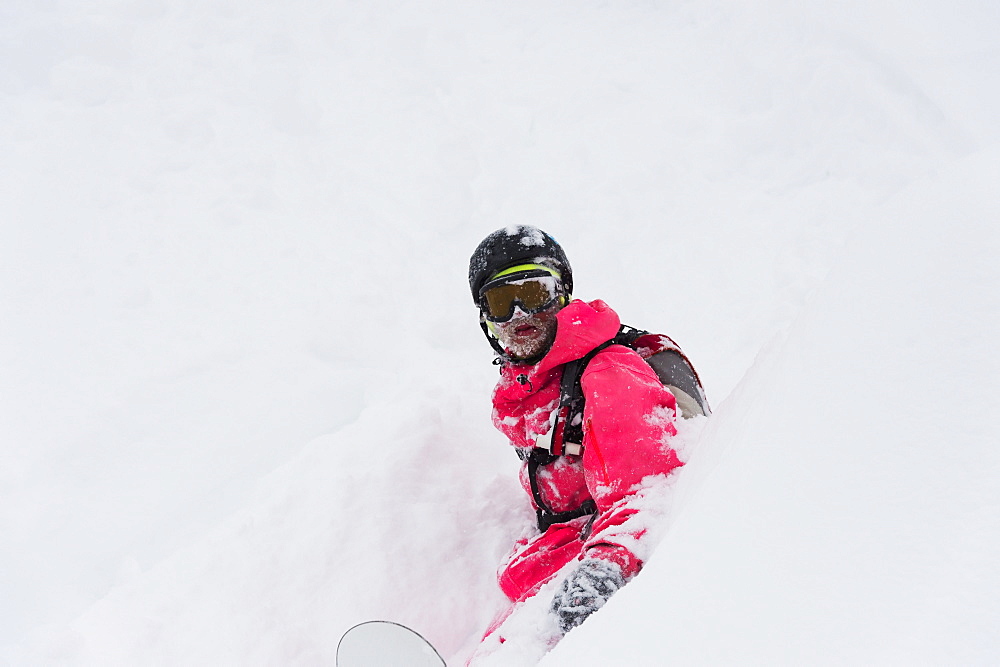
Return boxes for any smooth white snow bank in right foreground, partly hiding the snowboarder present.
[544,149,1000,665]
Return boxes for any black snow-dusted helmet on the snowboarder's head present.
[469,225,573,305]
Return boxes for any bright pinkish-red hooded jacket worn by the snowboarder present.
[493,300,683,599]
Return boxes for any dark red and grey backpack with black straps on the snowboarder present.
[518,325,711,532]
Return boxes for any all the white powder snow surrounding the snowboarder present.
[0,0,1000,665]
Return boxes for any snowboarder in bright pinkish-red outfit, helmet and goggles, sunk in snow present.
[469,225,705,641]
